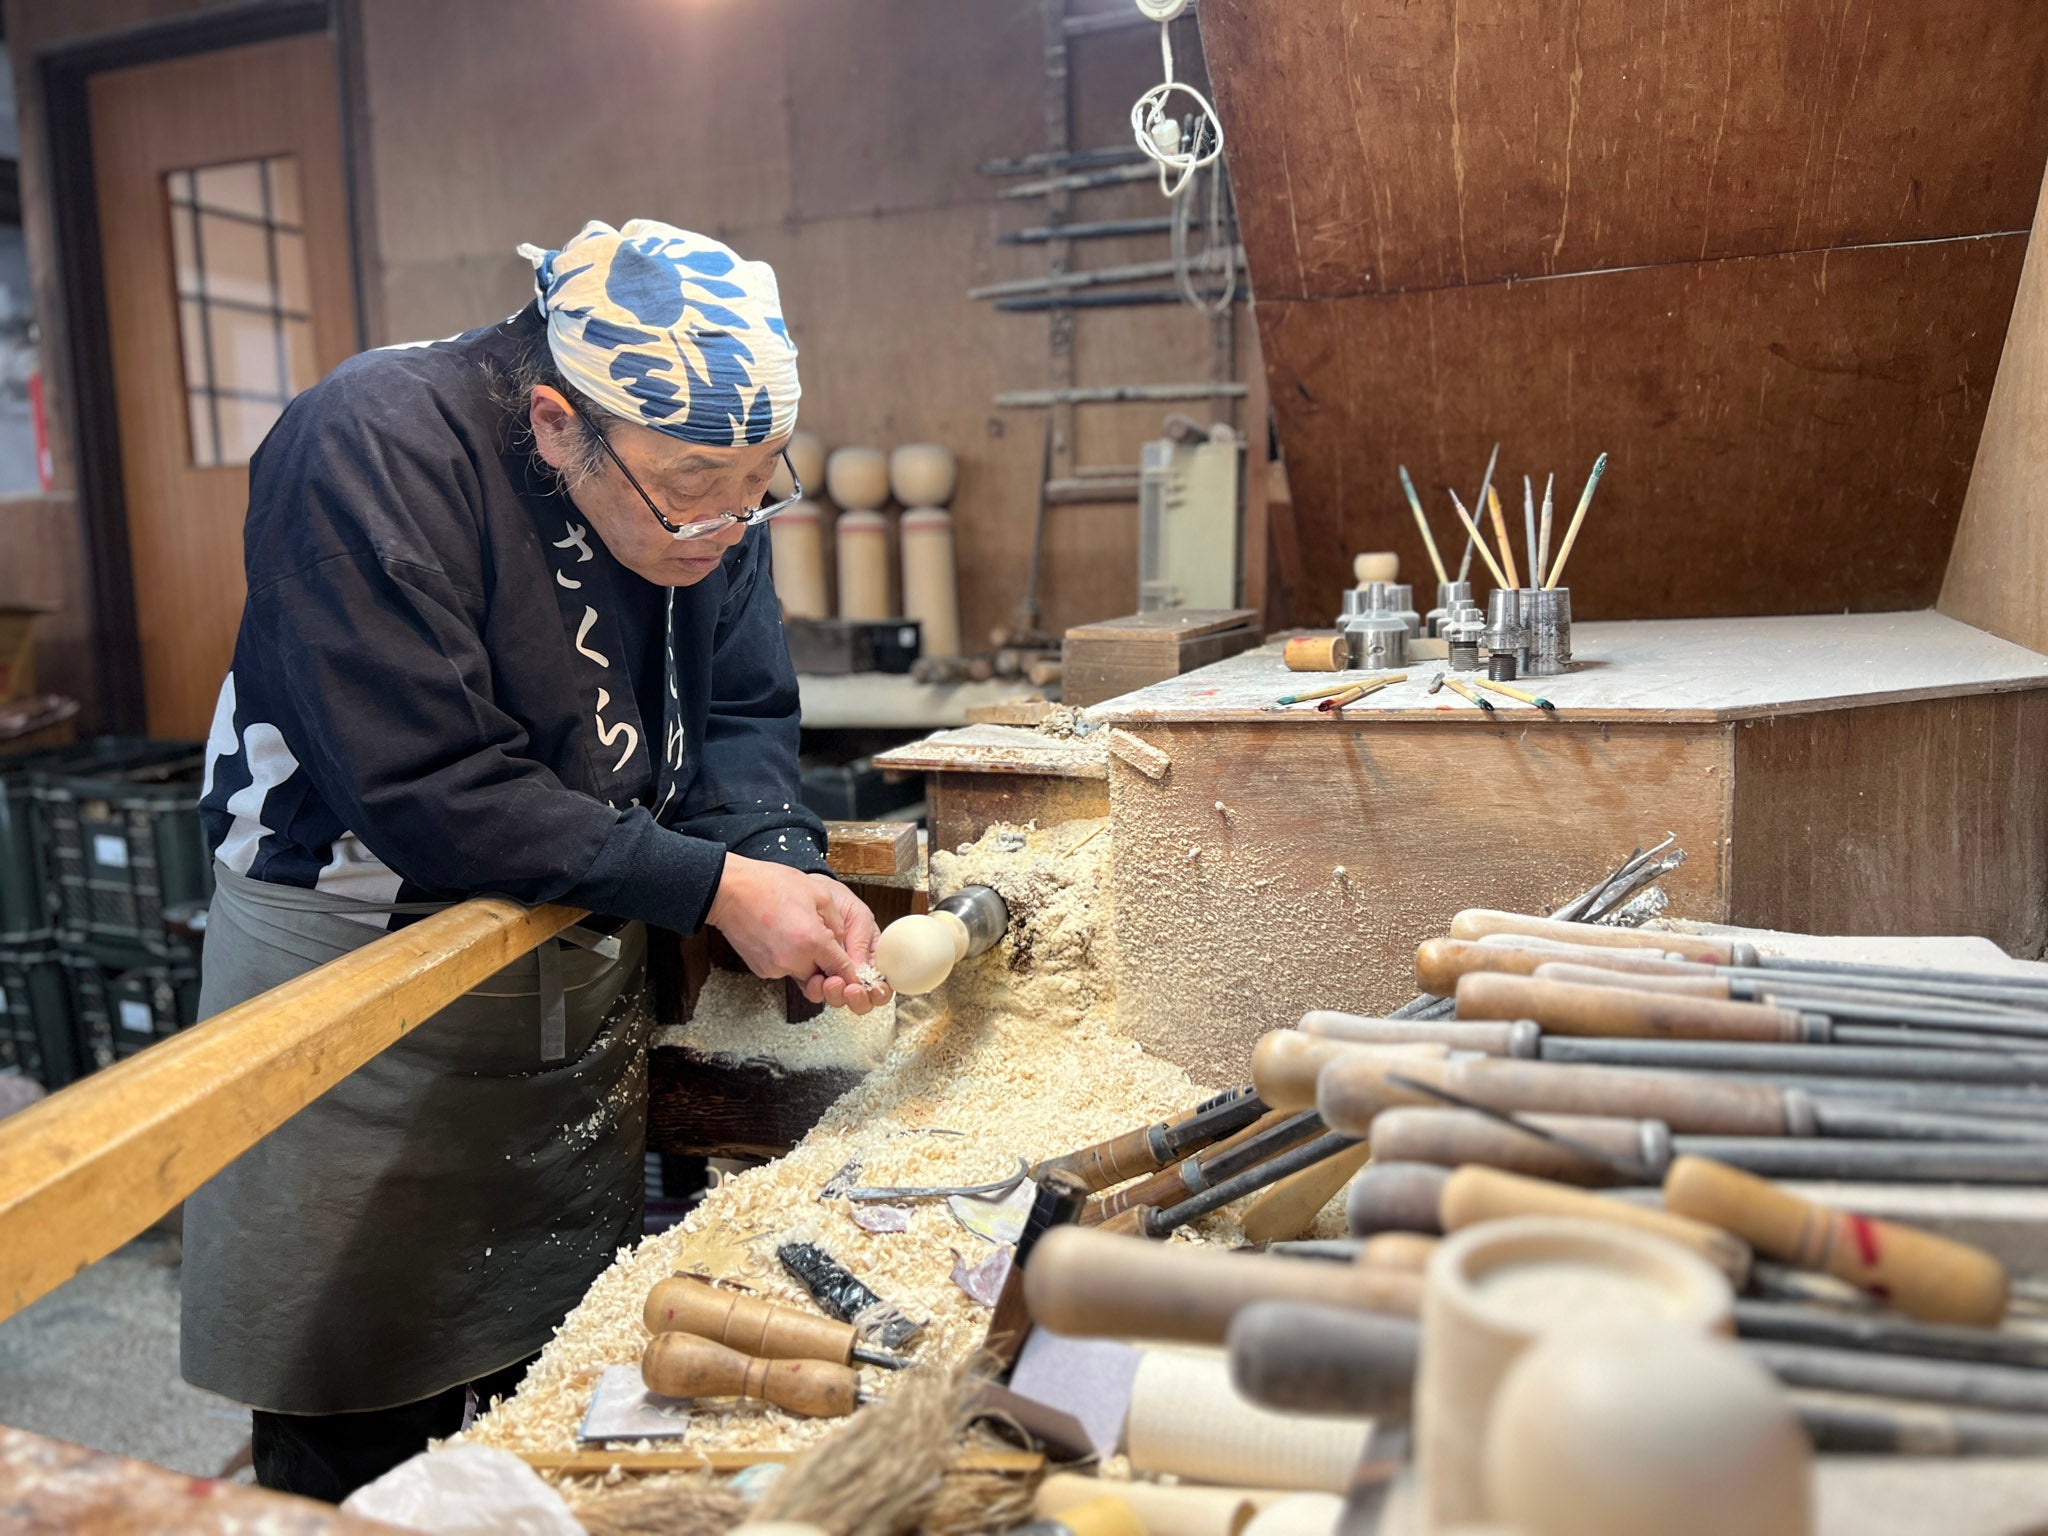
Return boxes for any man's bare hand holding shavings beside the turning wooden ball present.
[709,854,889,1014]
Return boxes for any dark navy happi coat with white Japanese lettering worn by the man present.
[201,307,825,932]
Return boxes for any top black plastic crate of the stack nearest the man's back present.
[35,741,213,961]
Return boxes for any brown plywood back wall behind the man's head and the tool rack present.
[362,0,1249,643]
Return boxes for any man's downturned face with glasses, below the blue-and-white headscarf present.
[528,385,788,586]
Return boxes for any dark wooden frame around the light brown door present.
[35,0,375,733]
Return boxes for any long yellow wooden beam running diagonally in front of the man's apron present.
[0,897,584,1317]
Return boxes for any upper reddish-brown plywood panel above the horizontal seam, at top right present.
[1202,0,2048,299]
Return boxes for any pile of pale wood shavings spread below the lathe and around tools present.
[461,821,1341,1499]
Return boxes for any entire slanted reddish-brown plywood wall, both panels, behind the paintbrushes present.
[1202,0,2048,621]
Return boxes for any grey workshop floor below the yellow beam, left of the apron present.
[0,1233,250,1477]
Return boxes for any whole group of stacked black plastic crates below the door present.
[0,737,211,1087]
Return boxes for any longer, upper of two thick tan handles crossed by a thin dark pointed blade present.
[1315,1059,1808,1137]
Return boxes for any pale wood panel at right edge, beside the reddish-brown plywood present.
[1942,166,2048,651]
